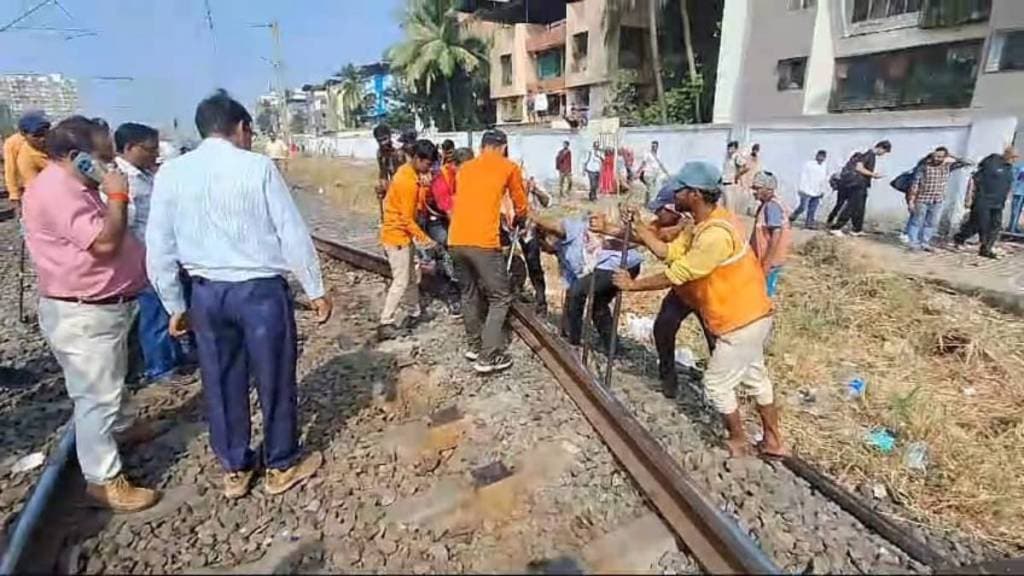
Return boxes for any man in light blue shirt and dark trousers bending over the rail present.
[530,213,643,349]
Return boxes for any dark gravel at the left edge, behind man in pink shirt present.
[0,219,65,529]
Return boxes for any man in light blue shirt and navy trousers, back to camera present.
[145,90,332,498]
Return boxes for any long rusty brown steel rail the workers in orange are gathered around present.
[313,237,780,574]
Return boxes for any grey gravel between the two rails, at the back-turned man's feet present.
[68,258,695,573]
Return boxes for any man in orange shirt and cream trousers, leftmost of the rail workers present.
[377,140,437,340]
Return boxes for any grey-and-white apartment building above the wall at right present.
[714,0,1024,123]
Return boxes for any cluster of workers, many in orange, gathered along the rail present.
[375,126,791,456]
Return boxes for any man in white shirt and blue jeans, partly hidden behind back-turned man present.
[114,122,193,382]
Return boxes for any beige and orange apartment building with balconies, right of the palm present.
[462,0,650,124]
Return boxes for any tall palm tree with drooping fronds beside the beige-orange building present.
[389,0,487,131]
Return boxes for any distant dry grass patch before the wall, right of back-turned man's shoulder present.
[287,157,380,214]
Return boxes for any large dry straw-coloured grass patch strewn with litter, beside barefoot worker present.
[753,237,1024,550]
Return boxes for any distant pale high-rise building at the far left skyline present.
[0,74,79,120]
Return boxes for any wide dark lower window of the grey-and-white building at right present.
[829,41,982,112]
